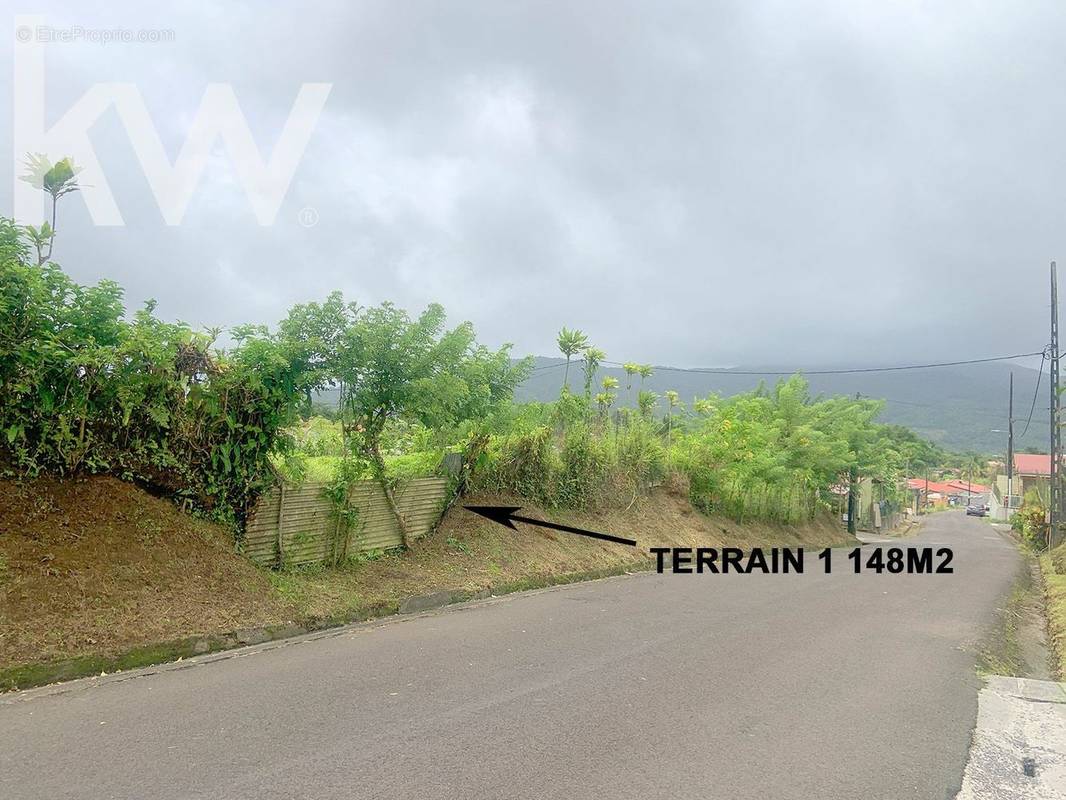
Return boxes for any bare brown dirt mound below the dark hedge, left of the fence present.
[0,477,292,668]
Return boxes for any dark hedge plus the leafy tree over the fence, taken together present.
[0,157,528,530]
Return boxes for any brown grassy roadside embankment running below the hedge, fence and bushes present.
[0,477,849,690]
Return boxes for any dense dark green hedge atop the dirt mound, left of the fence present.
[0,223,306,519]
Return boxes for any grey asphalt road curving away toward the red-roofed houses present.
[0,513,1020,800]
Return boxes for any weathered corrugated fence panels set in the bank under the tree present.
[244,478,448,565]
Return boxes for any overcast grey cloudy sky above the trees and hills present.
[0,0,1066,367]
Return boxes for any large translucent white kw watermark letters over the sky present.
[12,16,333,226]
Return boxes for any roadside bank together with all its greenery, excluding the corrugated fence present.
[0,166,963,686]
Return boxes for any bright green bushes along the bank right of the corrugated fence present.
[474,339,929,523]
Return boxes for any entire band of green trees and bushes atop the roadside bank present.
[0,159,950,540]
